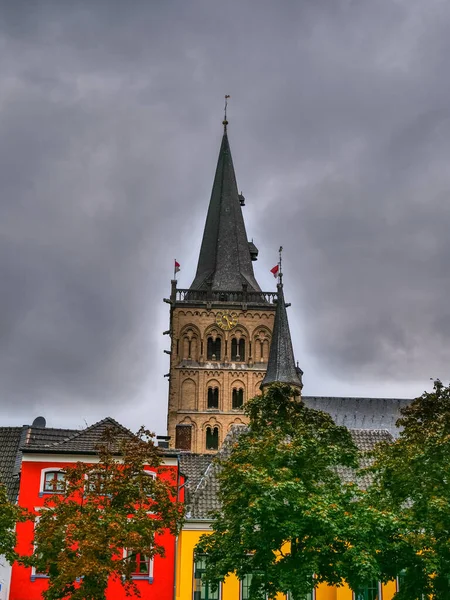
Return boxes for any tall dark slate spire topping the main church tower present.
[190,130,260,291]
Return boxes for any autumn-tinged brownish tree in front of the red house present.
[25,429,183,600]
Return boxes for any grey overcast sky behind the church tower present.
[0,0,450,434]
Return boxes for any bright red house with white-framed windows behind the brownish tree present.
[9,418,183,600]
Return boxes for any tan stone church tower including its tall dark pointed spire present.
[168,120,277,453]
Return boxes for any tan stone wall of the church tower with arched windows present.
[168,302,275,452]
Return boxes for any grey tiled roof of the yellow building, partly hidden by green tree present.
[186,426,393,520]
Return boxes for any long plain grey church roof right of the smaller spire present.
[302,396,412,437]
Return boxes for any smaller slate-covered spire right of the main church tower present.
[261,281,303,389]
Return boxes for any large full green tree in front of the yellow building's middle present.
[197,384,394,599]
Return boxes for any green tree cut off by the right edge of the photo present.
[369,380,450,600]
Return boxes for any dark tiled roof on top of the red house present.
[22,417,134,454]
